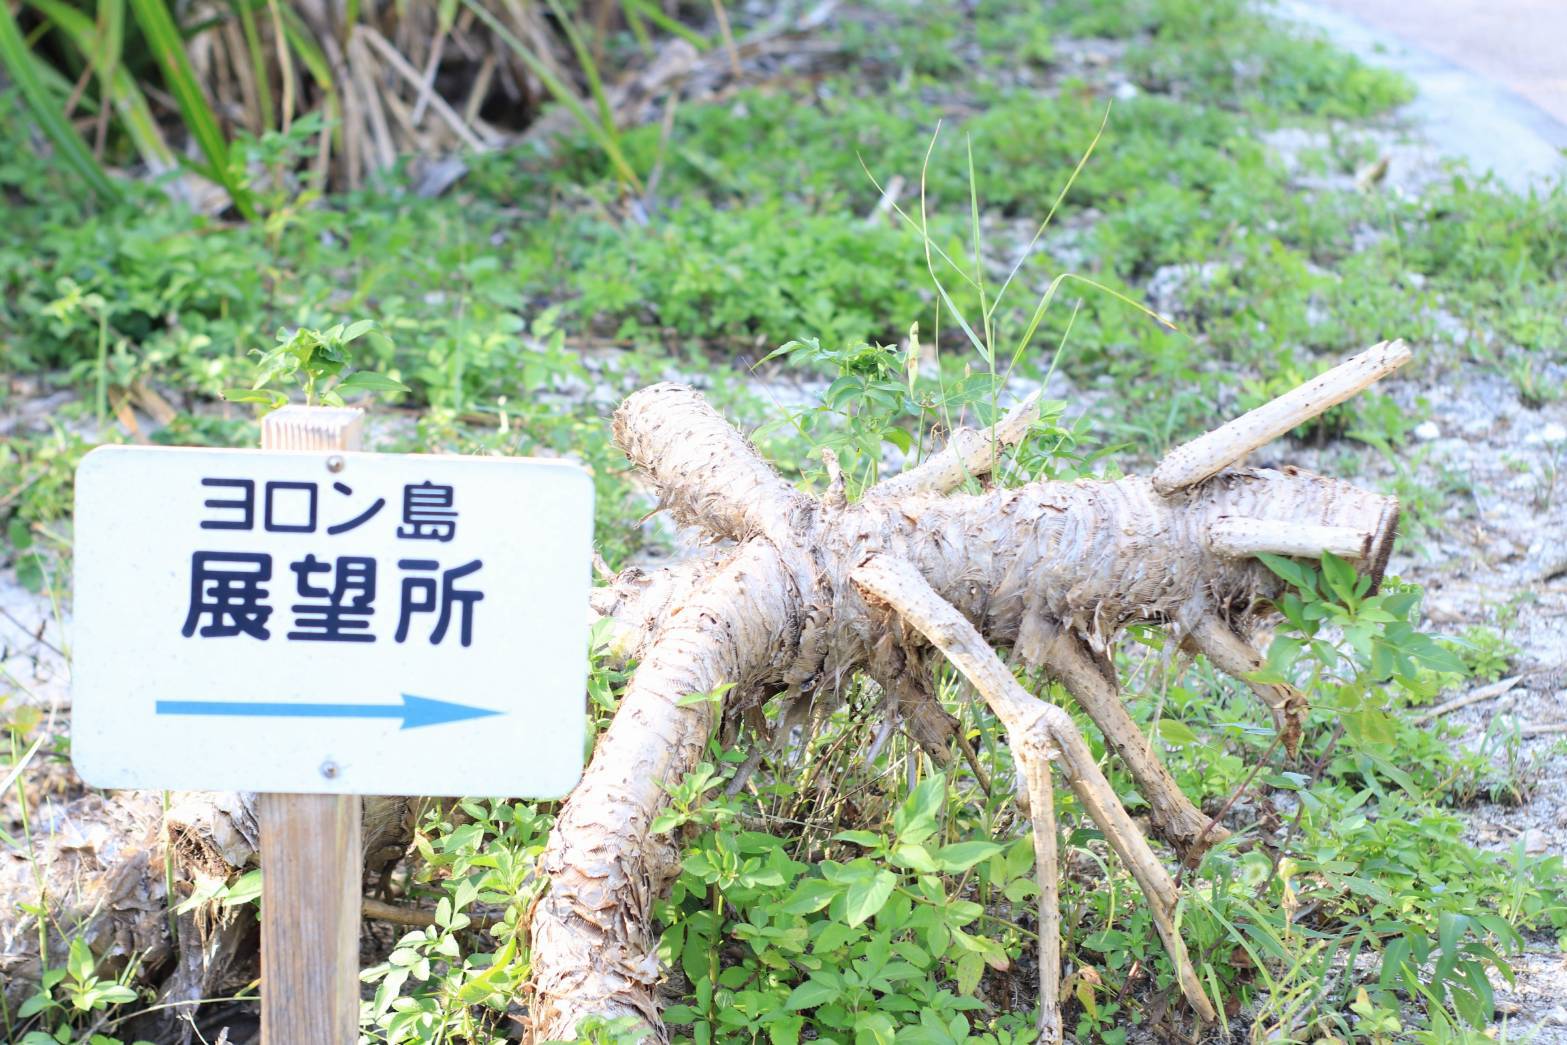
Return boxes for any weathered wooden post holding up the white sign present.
[260,406,364,1045]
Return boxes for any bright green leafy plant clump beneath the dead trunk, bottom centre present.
[657,763,1034,1042]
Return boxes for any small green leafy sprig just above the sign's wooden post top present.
[224,320,409,410]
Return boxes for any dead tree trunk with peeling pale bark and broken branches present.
[533,342,1409,1040]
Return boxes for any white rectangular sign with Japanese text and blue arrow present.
[71,447,592,797]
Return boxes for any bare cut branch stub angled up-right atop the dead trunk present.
[1153,342,1412,497]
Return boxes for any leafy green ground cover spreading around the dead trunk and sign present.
[0,0,1567,1042]
